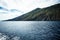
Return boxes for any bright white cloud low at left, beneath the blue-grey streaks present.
[0,12,23,20]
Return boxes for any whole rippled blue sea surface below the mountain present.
[0,21,60,40]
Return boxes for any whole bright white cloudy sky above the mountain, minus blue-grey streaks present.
[0,0,60,20]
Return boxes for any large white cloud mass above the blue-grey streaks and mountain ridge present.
[0,0,60,12]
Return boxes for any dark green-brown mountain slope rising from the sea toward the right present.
[6,4,60,21]
